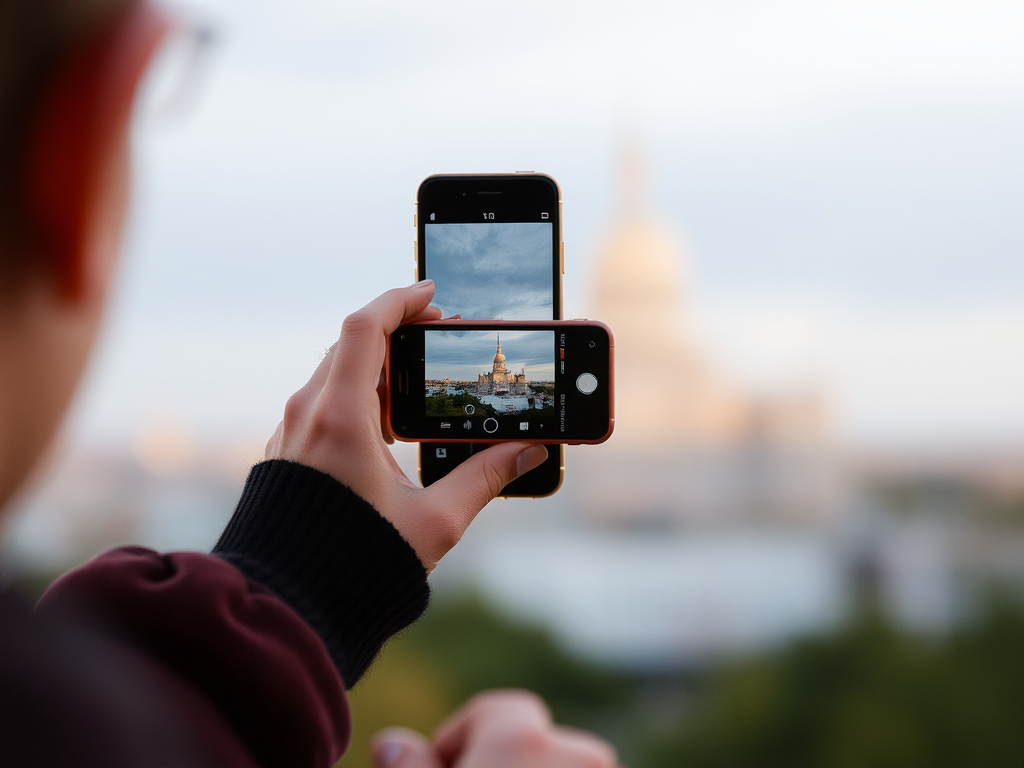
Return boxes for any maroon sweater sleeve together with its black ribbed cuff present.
[39,461,429,766]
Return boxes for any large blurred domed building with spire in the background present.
[566,156,837,524]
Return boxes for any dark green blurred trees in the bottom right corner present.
[638,603,1024,768]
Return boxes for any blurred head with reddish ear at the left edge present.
[0,0,169,506]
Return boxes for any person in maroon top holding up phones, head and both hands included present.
[0,0,615,768]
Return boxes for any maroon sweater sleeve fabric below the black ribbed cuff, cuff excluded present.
[37,547,350,768]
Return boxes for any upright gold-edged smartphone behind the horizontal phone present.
[415,173,565,498]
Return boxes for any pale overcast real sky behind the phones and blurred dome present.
[66,0,1024,454]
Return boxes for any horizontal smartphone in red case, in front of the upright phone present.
[386,321,614,444]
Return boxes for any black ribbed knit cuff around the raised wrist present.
[213,460,430,688]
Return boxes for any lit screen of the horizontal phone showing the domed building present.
[424,331,556,437]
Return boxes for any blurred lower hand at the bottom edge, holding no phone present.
[373,690,618,768]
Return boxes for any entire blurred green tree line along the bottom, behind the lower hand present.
[340,597,1024,768]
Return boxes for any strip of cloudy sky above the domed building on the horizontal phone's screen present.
[424,331,555,381]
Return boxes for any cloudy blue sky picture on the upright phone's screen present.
[424,222,554,319]
